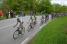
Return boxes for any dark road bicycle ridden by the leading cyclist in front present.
[13,27,25,40]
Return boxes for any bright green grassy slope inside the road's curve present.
[28,17,67,44]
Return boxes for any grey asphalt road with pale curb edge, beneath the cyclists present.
[0,16,51,44]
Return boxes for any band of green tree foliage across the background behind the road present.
[3,0,67,14]
